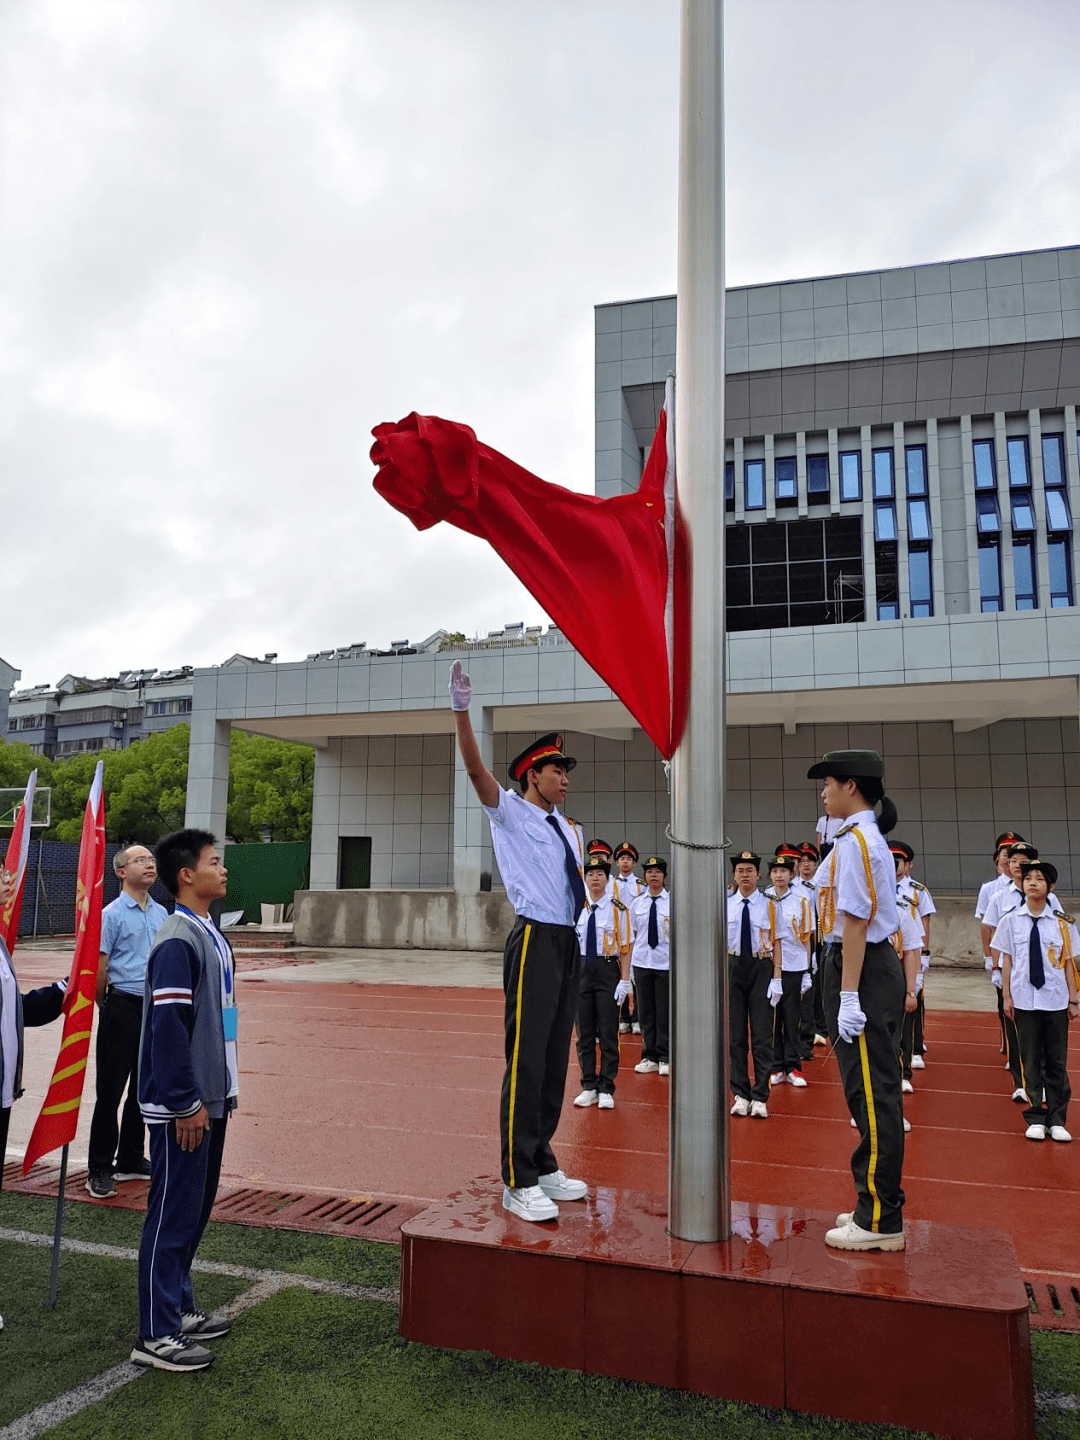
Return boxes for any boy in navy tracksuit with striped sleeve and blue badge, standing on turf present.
[131,829,238,1371]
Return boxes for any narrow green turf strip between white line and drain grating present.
[0,1191,400,1289]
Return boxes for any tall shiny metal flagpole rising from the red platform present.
[668,0,732,1241]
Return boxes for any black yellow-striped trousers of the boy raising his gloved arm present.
[500,916,582,1189]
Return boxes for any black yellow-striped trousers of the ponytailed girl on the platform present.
[822,940,906,1236]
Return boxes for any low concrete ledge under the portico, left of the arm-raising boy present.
[292,890,514,950]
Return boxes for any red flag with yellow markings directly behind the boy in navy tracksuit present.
[23,760,105,1175]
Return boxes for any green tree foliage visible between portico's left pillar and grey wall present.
[228,730,315,844]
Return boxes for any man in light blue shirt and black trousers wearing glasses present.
[86,845,168,1200]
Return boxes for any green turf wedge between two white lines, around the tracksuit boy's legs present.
[0,1241,249,1426]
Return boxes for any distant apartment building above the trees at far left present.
[0,661,192,760]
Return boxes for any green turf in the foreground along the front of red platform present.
[50,1290,933,1440]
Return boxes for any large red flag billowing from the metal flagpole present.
[372,388,688,757]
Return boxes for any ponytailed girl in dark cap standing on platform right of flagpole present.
[806,750,907,1250]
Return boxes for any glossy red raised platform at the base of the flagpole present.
[400,1179,1034,1440]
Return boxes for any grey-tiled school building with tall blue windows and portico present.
[187,246,1080,943]
